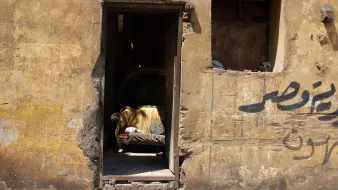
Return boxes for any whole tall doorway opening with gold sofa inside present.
[100,3,183,184]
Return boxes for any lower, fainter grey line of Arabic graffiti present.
[283,129,338,165]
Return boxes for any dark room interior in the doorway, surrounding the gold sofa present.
[103,5,178,179]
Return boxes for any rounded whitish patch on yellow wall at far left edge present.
[0,120,19,146]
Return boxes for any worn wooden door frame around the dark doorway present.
[99,3,184,189]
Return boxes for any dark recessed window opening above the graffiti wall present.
[212,0,281,72]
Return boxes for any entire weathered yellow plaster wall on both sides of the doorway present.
[0,0,338,189]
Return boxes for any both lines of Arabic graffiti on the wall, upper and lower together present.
[239,81,338,165]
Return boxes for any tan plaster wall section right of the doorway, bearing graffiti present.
[179,0,338,189]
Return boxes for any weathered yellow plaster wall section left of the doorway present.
[0,0,101,189]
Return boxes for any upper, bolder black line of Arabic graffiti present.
[239,81,338,127]
